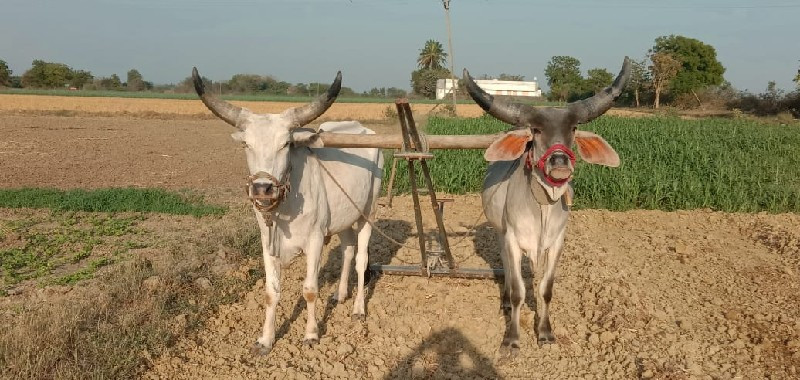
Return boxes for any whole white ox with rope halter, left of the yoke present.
[192,68,383,354]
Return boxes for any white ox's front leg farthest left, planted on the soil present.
[252,221,281,355]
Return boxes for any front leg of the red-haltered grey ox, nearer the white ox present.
[500,231,525,357]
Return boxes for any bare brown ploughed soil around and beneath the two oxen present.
[0,108,800,379]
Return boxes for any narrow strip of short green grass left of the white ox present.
[0,188,225,217]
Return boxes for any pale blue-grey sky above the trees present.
[0,0,800,92]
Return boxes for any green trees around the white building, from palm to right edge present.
[411,35,800,118]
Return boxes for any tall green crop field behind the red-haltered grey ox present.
[384,116,800,213]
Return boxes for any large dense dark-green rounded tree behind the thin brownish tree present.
[650,35,725,95]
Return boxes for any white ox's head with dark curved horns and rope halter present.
[192,68,342,211]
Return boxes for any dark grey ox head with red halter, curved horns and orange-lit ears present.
[464,57,630,186]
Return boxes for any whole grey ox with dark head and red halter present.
[464,57,630,355]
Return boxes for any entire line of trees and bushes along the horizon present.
[0,35,800,117]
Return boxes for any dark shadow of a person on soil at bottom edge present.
[384,327,500,380]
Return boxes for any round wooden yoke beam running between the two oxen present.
[319,132,502,149]
